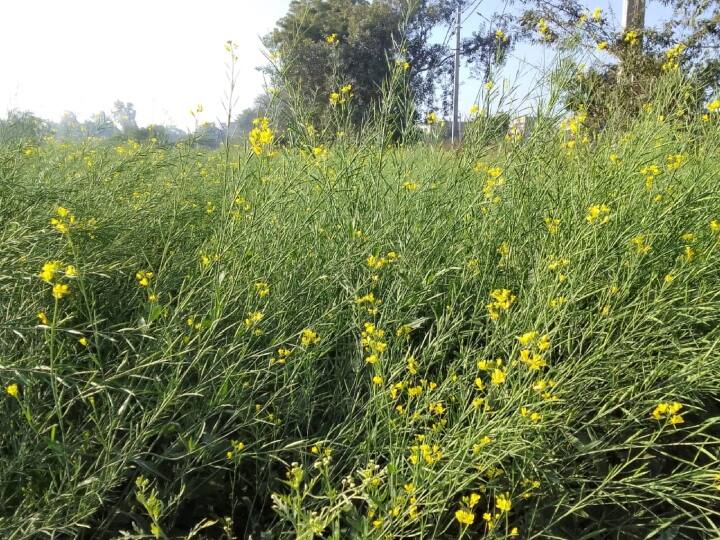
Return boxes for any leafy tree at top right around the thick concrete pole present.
[515,0,720,123]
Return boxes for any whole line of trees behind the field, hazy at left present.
[0,0,720,148]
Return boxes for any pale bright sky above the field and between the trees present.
[0,0,662,129]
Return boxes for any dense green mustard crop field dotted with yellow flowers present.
[0,82,720,540]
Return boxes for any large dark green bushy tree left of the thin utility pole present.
[265,0,512,127]
